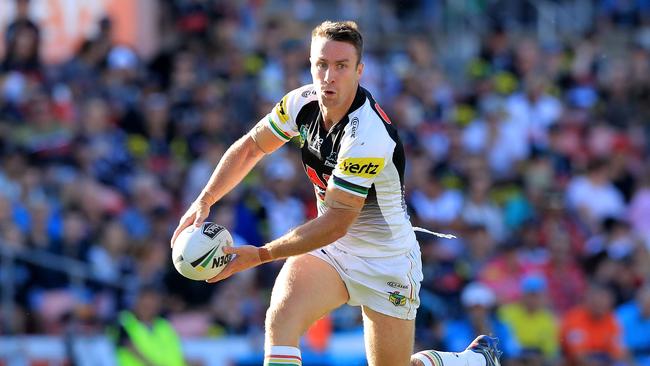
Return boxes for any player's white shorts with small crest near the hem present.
[309,243,423,320]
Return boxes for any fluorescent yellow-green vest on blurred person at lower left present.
[117,311,185,366]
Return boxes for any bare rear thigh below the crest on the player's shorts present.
[363,306,415,366]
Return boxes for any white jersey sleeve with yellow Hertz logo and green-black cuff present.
[328,122,394,197]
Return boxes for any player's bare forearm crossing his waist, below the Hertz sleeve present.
[262,209,357,261]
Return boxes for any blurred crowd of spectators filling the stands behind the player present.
[0,0,650,365]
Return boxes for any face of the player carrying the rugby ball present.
[309,37,363,108]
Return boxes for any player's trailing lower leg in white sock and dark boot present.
[411,335,501,366]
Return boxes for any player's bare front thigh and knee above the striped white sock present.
[266,254,349,347]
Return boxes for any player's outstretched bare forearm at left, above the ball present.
[199,135,264,205]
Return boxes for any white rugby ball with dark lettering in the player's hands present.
[172,222,232,281]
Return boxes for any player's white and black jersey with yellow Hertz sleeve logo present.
[264,85,417,257]
